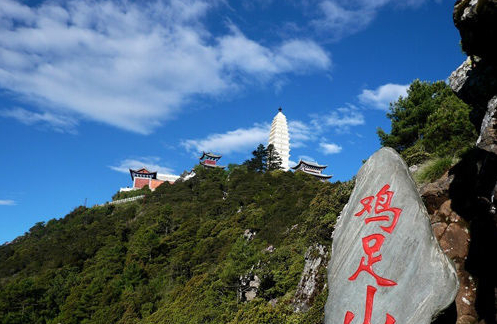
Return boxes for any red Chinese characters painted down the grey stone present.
[343,184,402,324]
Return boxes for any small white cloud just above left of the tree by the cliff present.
[358,83,409,110]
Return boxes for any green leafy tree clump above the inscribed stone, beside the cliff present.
[378,80,477,164]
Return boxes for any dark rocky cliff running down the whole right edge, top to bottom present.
[448,0,497,318]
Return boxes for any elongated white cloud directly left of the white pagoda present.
[181,124,270,154]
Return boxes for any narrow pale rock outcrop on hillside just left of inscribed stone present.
[293,244,328,312]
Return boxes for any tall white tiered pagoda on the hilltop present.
[268,107,290,171]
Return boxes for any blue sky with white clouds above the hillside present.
[0,0,464,243]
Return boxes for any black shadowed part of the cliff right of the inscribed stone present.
[449,149,497,324]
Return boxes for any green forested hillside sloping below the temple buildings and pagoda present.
[0,165,352,324]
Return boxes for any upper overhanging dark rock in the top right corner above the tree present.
[449,0,497,153]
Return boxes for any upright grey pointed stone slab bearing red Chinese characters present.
[325,148,458,324]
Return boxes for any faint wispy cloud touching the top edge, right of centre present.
[311,0,426,40]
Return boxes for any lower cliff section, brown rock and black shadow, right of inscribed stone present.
[420,150,497,324]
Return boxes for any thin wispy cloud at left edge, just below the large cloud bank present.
[0,108,78,133]
